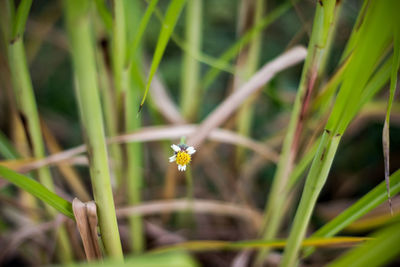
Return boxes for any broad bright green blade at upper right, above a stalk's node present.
[327,2,397,134]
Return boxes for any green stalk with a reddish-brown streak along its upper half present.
[258,0,336,263]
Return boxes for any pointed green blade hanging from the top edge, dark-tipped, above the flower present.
[138,0,186,113]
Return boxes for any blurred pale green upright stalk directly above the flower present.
[180,0,203,120]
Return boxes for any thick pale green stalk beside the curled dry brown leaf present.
[64,0,123,260]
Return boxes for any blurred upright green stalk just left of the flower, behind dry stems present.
[114,1,148,254]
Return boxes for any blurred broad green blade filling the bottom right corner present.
[328,224,400,267]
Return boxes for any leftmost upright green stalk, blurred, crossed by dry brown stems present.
[3,0,73,263]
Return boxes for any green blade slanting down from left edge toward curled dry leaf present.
[0,165,74,219]
